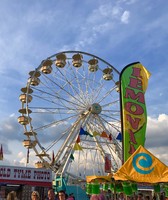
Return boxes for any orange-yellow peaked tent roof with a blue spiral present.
[113,146,168,183]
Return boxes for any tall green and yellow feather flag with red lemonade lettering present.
[120,62,150,162]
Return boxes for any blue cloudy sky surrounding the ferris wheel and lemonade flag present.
[0,0,168,168]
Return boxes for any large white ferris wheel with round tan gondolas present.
[18,51,122,179]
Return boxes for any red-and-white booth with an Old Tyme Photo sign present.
[0,165,52,200]
